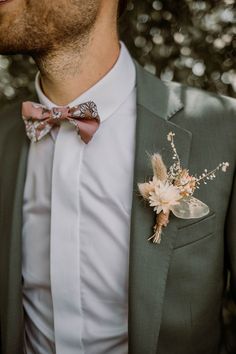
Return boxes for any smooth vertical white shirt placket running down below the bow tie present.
[50,123,85,354]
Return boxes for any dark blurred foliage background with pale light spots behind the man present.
[0,0,236,106]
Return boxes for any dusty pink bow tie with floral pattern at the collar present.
[22,101,100,144]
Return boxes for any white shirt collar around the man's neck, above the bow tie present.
[35,42,136,121]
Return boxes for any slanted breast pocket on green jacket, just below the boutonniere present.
[174,211,216,248]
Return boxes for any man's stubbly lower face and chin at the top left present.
[0,0,99,57]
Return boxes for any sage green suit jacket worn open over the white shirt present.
[0,63,236,354]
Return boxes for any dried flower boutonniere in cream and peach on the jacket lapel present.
[138,132,229,243]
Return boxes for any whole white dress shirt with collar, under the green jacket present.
[22,43,136,354]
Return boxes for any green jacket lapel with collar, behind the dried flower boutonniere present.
[129,63,191,354]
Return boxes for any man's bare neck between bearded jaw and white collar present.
[35,15,120,106]
